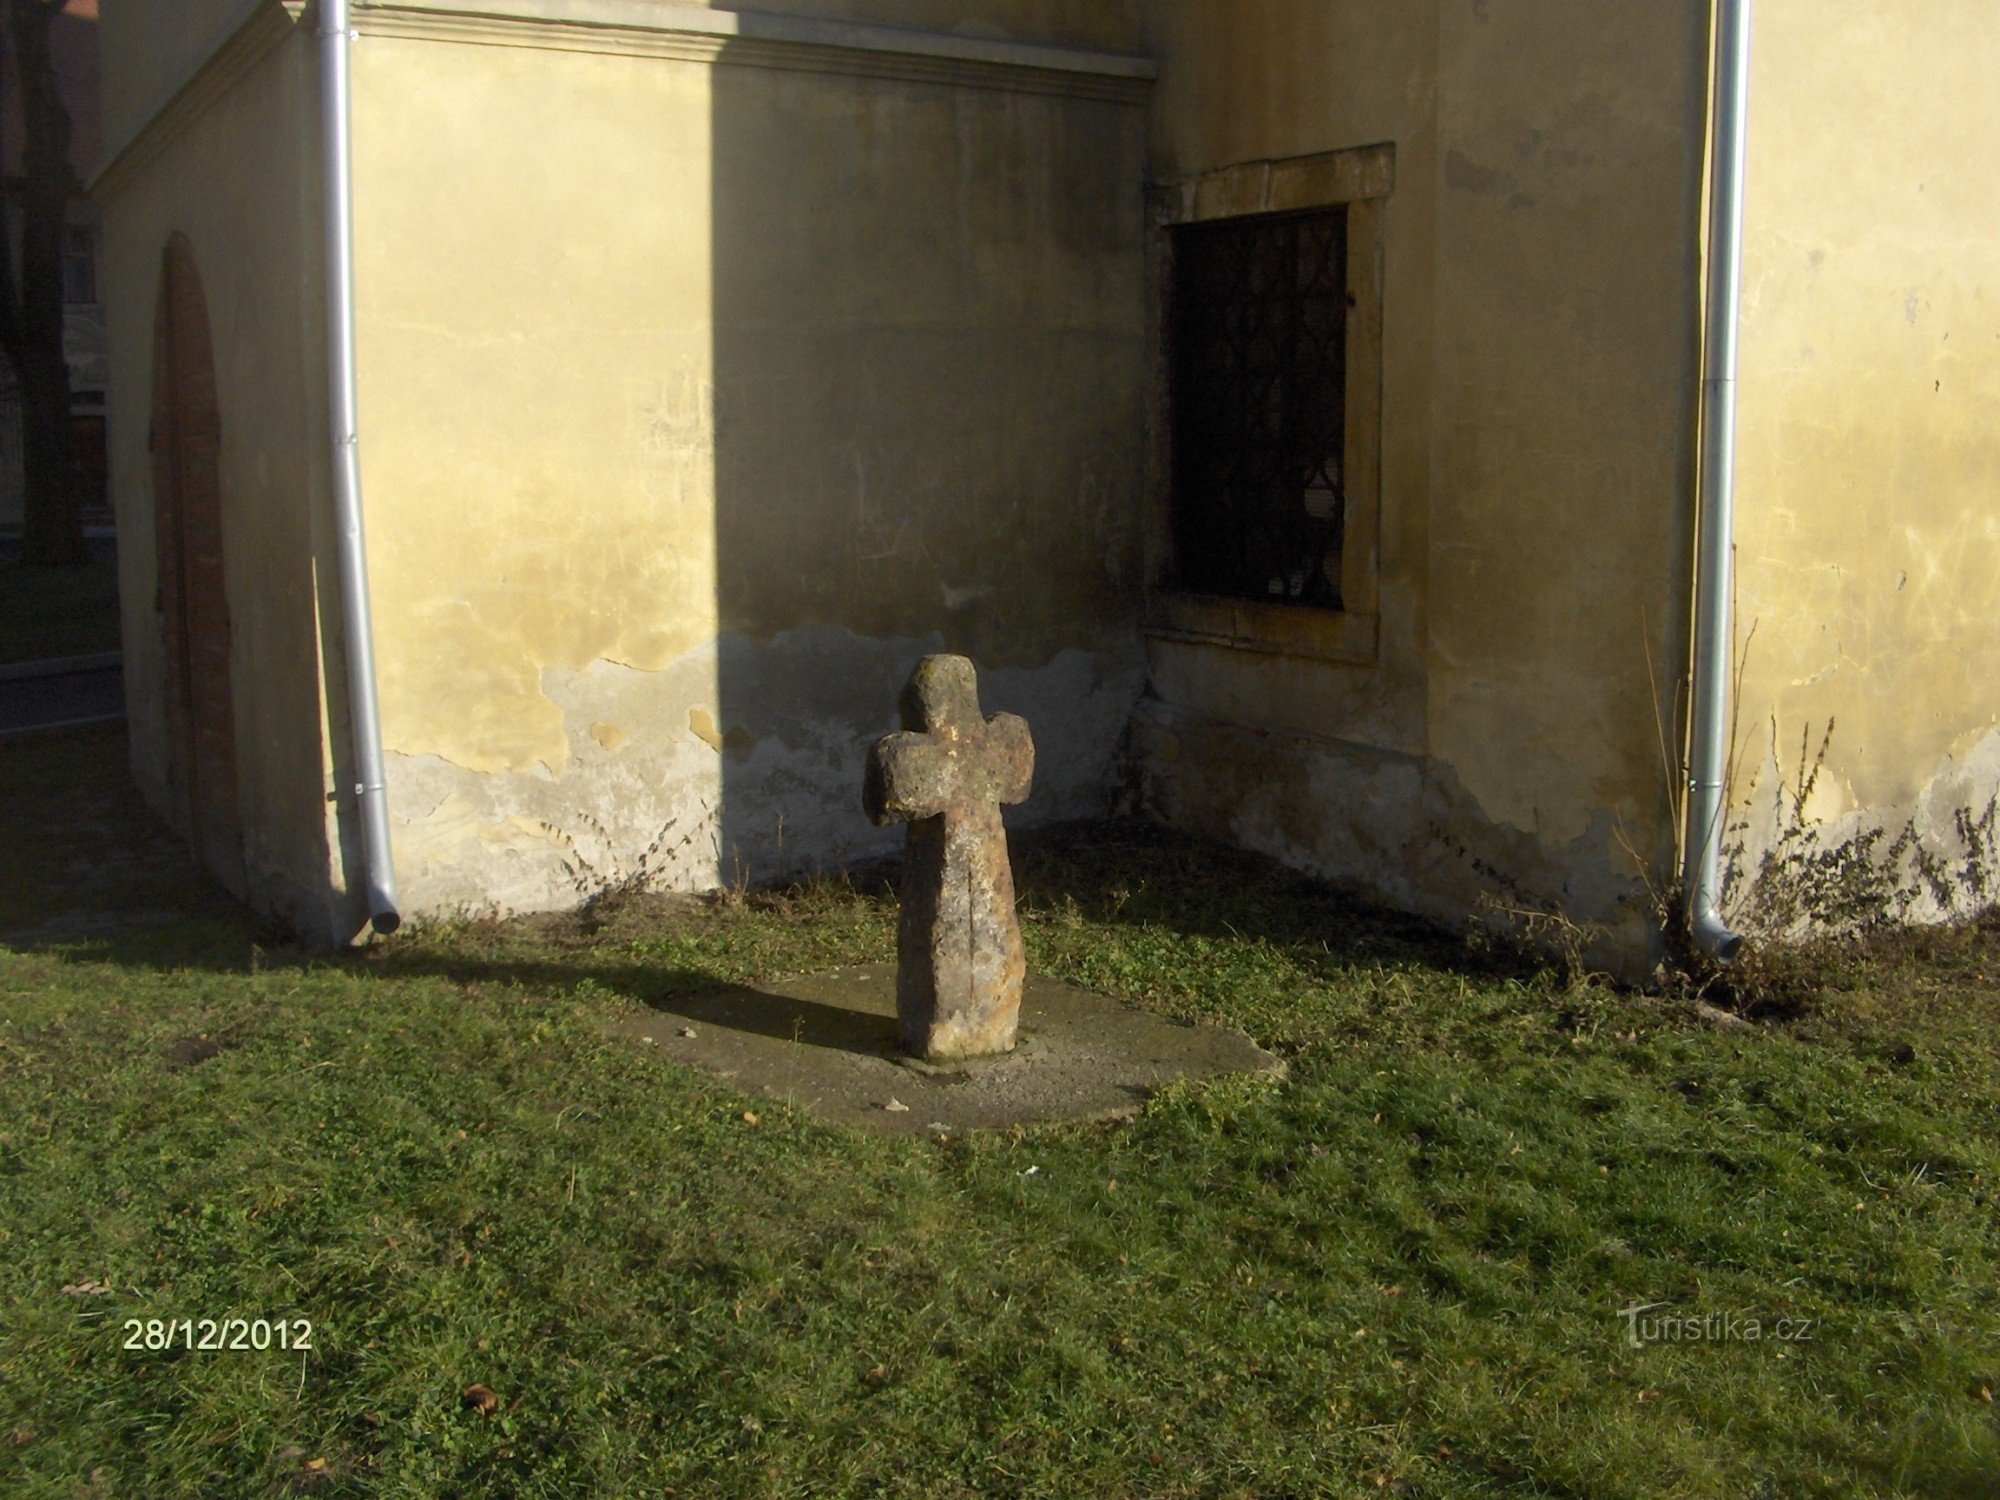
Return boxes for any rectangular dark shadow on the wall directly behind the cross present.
[708,58,1144,884]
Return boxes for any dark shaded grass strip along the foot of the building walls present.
[0,728,1534,1012]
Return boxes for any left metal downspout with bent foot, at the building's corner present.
[318,0,402,932]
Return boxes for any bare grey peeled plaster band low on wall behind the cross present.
[390,628,1144,914]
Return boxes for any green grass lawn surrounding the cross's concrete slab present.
[0,734,2000,1498]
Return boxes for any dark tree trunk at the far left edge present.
[0,0,86,568]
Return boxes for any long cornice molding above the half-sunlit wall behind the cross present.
[354,0,1158,104]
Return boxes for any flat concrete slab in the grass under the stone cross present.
[616,964,1284,1134]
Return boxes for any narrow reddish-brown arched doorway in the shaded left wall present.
[152,234,242,890]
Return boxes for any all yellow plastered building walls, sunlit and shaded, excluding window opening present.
[100,0,2000,968]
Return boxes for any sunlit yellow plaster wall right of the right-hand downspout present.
[1736,0,2000,916]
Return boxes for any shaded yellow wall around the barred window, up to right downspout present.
[1142,0,1706,940]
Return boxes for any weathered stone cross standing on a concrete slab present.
[862,656,1034,1062]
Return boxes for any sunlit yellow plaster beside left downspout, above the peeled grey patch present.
[354,36,716,772]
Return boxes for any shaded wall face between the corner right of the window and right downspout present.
[1430,0,1708,852]
